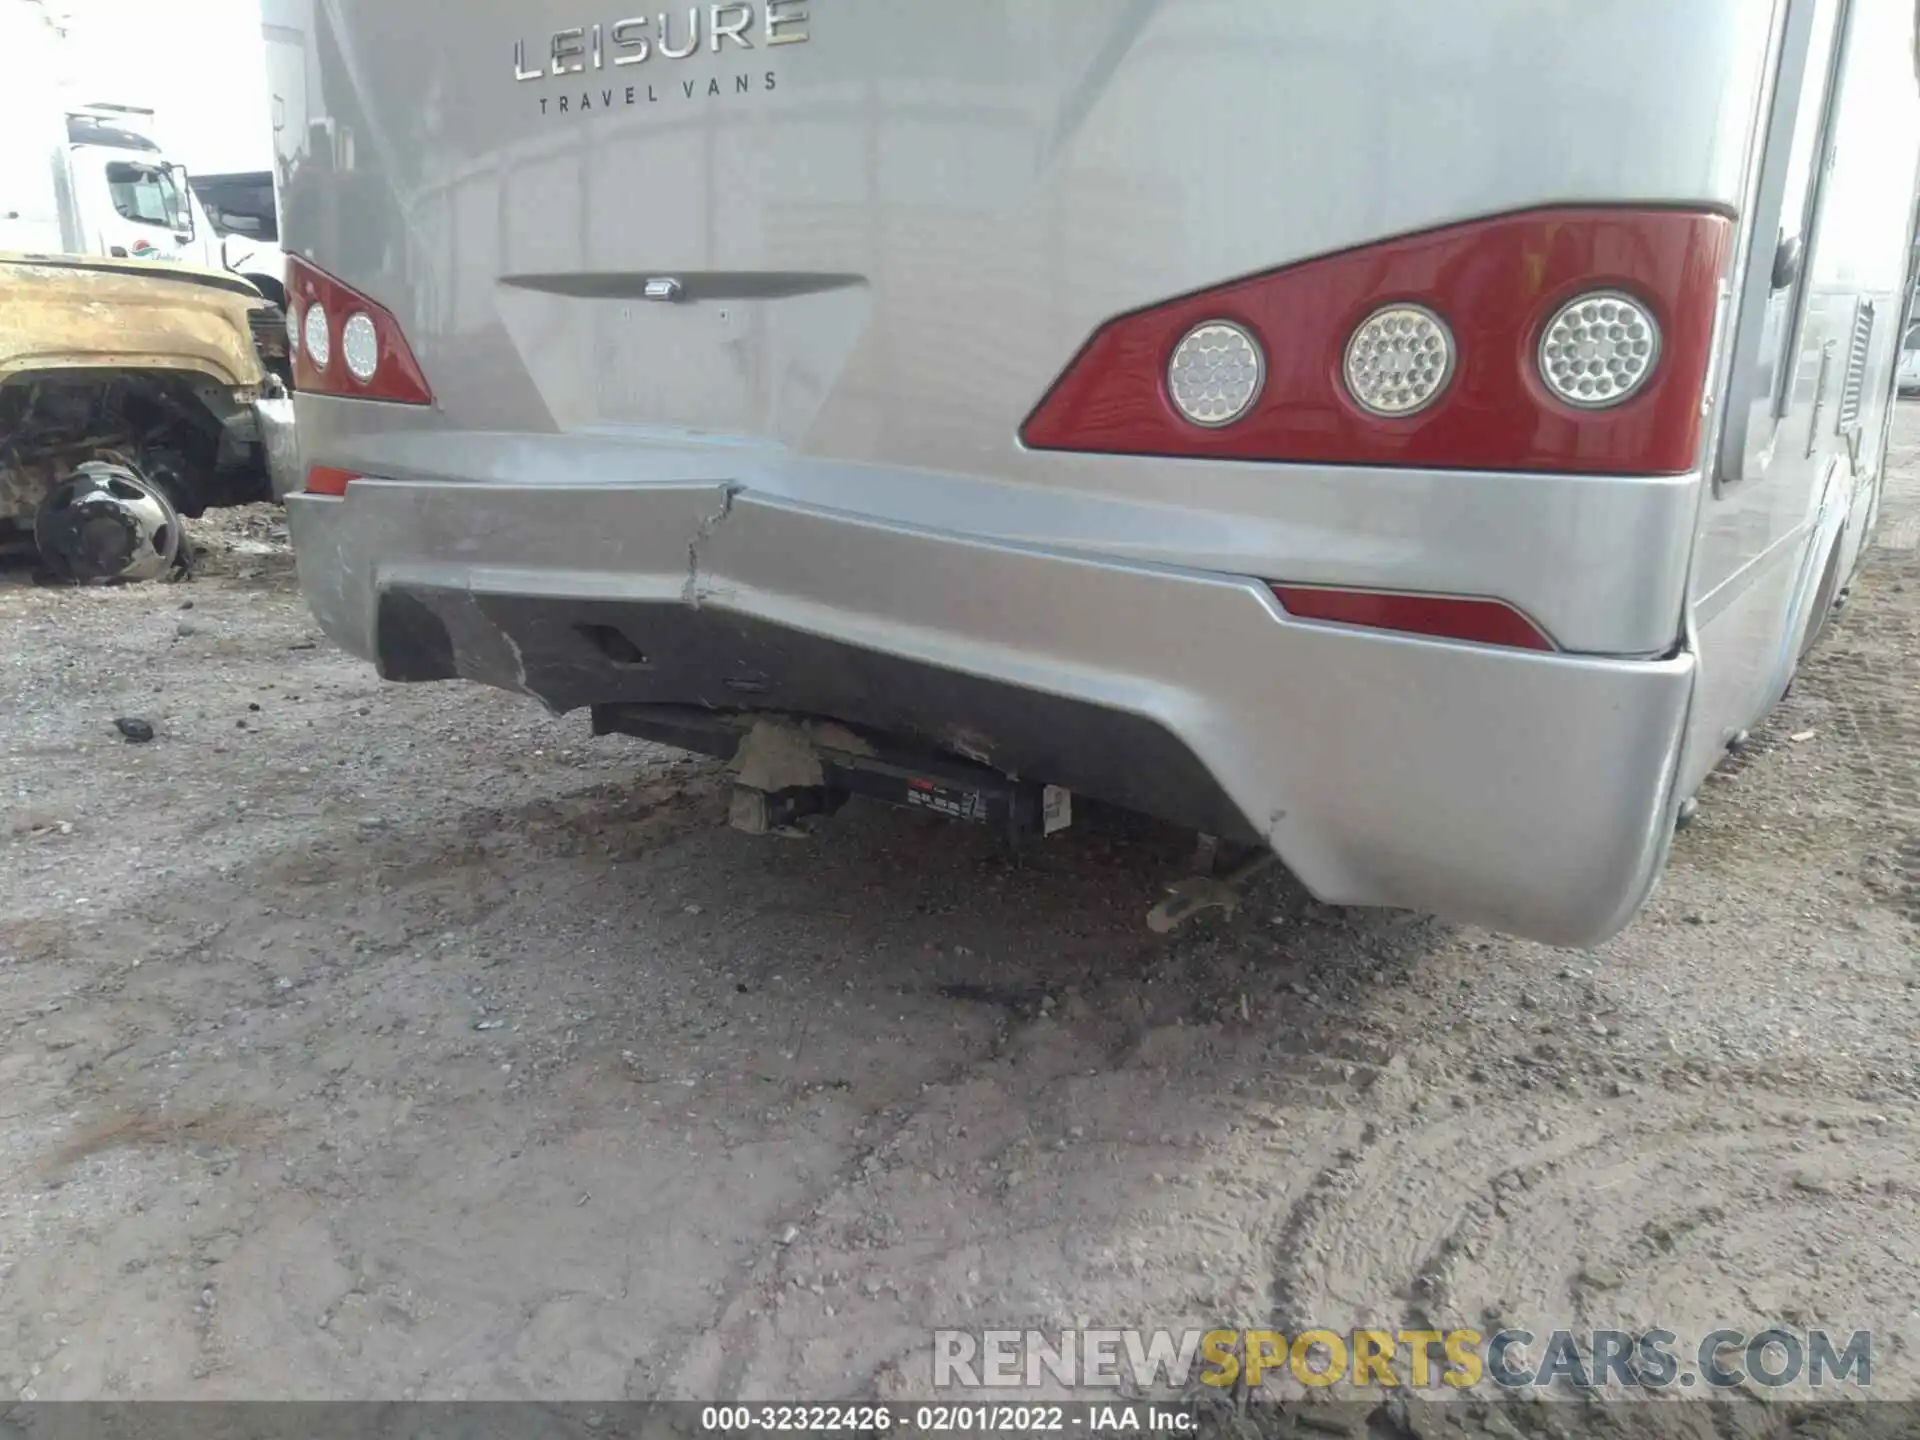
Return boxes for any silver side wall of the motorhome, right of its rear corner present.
[1682,0,1920,793]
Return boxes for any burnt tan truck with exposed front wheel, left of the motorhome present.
[0,255,286,584]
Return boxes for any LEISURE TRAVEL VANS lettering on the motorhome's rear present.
[513,0,812,115]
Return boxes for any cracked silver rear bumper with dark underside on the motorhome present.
[288,480,1693,945]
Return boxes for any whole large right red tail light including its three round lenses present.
[1020,207,1734,474]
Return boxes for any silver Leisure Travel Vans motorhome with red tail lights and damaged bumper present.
[263,0,1920,945]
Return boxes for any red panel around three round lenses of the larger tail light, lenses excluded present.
[1021,207,1732,474]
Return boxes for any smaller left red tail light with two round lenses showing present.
[286,257,434,405]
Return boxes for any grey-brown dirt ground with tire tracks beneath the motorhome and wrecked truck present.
[0,409,1920,1436]
